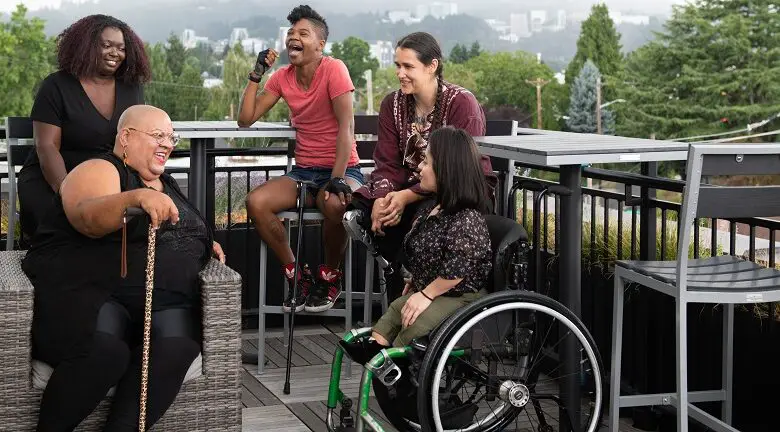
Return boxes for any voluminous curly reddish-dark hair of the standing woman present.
[57,15,152,84]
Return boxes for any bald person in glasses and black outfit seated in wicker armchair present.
[22,105,224,432]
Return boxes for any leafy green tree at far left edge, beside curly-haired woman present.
[0,4,55,116]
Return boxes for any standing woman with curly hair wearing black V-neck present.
[18,15,151,240]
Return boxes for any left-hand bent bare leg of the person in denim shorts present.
[246,177,298,265]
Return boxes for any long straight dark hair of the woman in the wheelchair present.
[428,126,490,214]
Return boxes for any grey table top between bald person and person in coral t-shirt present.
[173,121,295,138]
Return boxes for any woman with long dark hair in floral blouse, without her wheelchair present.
[341,127,491,364]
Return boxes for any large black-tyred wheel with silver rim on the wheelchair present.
[417,291,604,432]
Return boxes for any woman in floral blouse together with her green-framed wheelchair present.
[326,128,604,432]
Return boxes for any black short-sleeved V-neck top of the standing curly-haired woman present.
[25,71,144,172]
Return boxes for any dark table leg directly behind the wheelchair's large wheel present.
[558,165,582,431]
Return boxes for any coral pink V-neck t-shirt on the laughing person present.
[265,56,359,168]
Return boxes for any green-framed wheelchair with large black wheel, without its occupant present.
[326,195,604,432]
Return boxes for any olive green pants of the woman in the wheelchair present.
[373,290,487,347]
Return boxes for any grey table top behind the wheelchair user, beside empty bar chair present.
[474,131,689,166]
